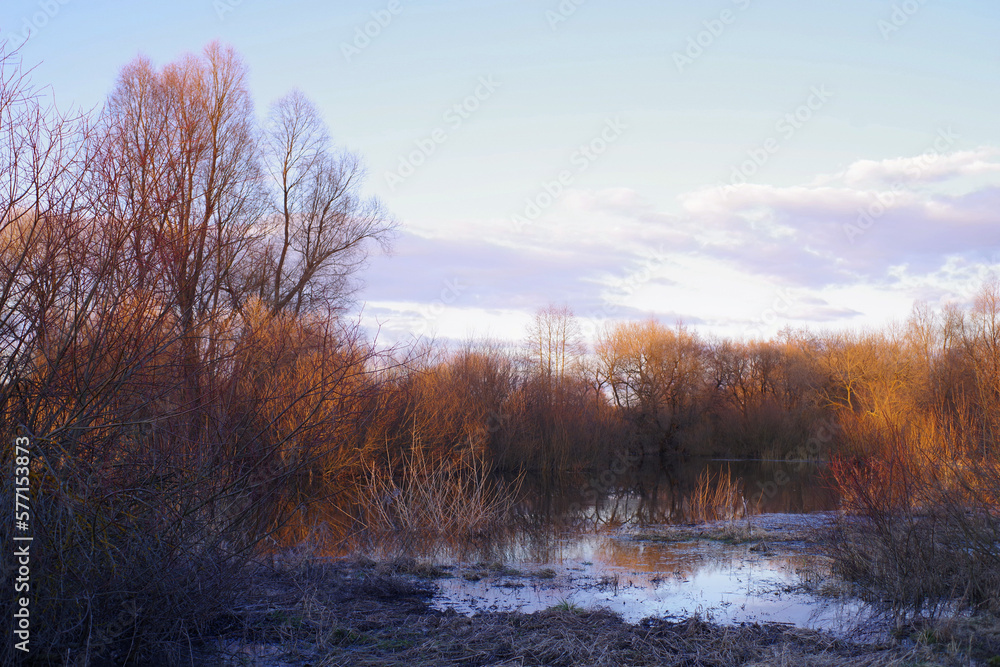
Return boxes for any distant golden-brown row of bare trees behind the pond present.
[386,288,1000,472]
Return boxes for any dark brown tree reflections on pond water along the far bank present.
[278,460,839,563]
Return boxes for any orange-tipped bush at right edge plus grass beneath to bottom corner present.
[829,420,1000,665]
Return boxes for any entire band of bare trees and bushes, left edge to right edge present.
[0,44,1000,664]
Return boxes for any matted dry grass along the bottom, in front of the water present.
[203,564,969,667]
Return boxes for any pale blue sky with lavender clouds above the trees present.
[0,0,1000,341]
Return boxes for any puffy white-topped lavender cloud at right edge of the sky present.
[681,149,1000,288]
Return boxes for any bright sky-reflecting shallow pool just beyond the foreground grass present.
[433,514,868,635]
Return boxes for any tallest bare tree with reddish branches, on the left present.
[98,43,262,440]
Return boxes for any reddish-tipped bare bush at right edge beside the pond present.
[831,432,1000,615]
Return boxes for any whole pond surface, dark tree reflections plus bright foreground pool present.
[280,461,862,631]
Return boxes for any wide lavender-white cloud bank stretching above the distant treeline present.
[367,148,1000,342]
